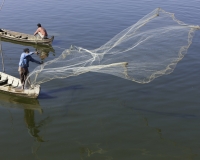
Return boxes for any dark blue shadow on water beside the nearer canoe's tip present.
[38,85,84,99]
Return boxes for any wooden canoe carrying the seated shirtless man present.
[0,29,54,45]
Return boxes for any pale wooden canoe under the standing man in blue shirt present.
[0,72,40,98]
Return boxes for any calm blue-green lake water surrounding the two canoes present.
[0,0,200,160]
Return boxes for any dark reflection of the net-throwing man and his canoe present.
[0,92,50,154]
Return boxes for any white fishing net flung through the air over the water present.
[25,8,199,85]
